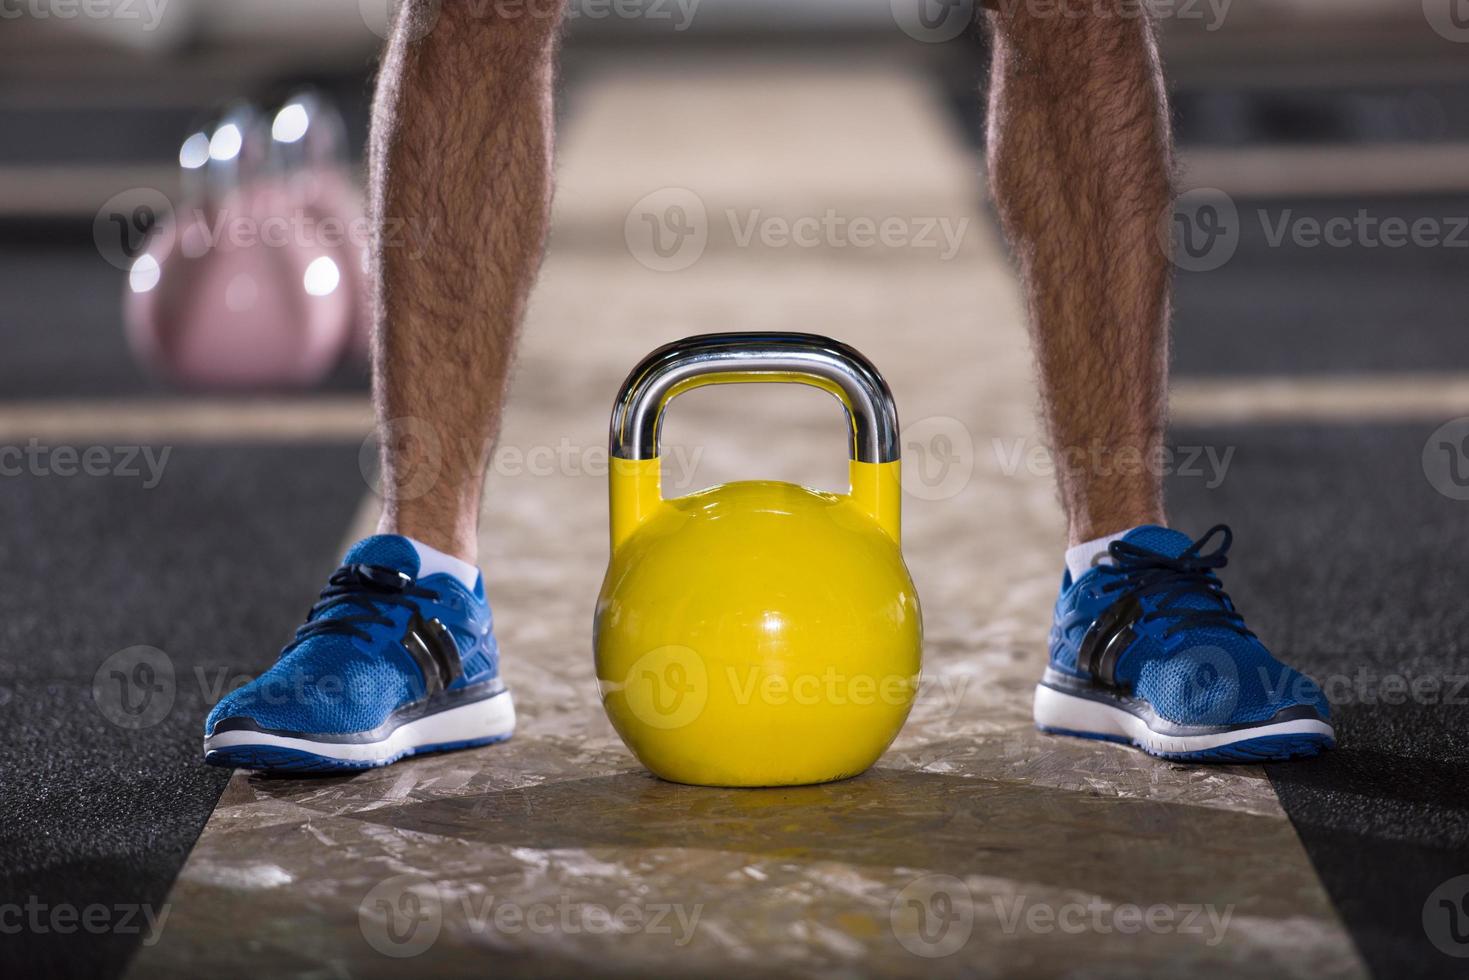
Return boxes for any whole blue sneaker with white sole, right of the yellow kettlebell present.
[1036,525,1335,763]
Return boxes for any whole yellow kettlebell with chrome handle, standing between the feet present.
[593,334,923,786]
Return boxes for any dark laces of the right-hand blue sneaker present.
[1097,525,1255,639]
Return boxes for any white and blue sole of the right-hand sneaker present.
[1036,683,1337,763]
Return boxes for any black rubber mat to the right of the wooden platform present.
[1168,422,1469,977]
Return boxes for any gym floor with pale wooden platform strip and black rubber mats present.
[0,13,1469,977]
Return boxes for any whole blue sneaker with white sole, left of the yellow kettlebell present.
[204,535,516,773]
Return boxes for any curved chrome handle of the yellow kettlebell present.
[611,334,899,463]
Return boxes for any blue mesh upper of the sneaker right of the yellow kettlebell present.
[1050,525,1329,726]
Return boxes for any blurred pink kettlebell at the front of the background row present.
[125,101,355,389]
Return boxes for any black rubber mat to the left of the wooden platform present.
[0,441,366,977]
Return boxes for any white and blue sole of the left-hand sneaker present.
[204,691,516,773]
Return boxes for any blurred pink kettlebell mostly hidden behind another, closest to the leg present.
[270,88,372,364]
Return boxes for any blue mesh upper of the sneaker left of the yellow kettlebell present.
[204,535,499,735]
